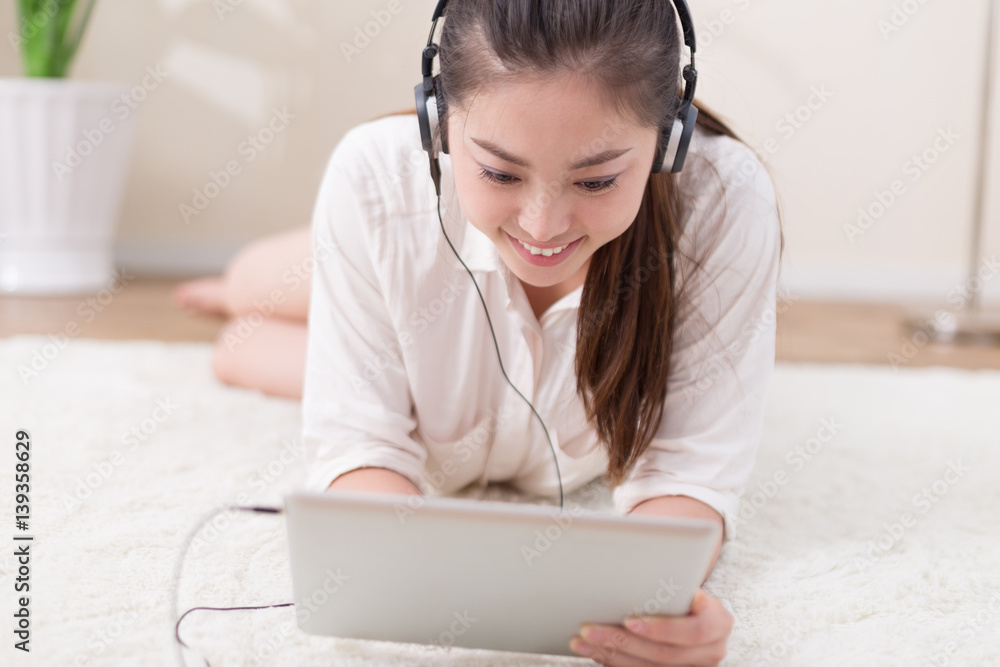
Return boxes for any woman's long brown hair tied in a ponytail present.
[376,0,783,488]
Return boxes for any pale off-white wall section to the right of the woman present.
[692,0,1000,301]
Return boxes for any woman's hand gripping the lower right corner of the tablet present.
[570,589,733,667]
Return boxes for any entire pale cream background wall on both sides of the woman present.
[0,0,1000,301]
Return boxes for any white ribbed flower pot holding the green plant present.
[0,78,135,294]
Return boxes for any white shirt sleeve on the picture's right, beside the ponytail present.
[612,138,781,542]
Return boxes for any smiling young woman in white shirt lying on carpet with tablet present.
[178,0,782,666]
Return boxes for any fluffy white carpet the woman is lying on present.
[0,336,1000,666]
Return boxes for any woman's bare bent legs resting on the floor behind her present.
[174,226,314,399]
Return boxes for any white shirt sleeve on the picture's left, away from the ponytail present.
[302,126,427,491]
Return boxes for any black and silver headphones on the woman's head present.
[413,0,698,194]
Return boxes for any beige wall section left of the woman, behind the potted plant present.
[0,0,436,273]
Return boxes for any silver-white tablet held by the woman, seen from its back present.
[285,491,721,655]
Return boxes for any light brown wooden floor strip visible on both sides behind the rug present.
[0,278,1000,369]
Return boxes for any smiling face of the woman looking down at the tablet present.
[448,76,659,288]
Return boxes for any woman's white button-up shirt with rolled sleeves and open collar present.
[302,115,779,541]
